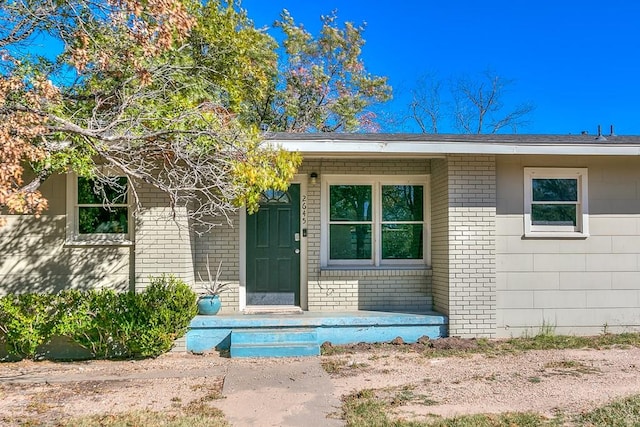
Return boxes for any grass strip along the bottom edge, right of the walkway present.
[342,388,640,427]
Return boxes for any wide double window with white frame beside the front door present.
[322,176,428,266]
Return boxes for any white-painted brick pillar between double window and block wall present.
[431,155,496,337]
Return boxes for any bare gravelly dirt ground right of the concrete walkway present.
[331,348,640,419]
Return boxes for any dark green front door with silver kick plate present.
[247,184,300,306]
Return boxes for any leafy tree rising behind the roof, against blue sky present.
[253,10,391,132]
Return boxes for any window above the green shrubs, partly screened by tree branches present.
[67,174,130,243]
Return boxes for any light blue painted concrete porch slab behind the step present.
[186,311,448,353]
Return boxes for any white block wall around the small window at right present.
[496,156,640,336]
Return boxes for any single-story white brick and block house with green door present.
[0,134,640,354]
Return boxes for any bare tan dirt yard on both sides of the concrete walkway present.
[0,345,640,425]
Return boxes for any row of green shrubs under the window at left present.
[0,276,197,359]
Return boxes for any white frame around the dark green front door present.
[238,174,309,311]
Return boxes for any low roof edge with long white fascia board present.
[264,133,640,158]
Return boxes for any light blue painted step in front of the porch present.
[230,328,320,357]
